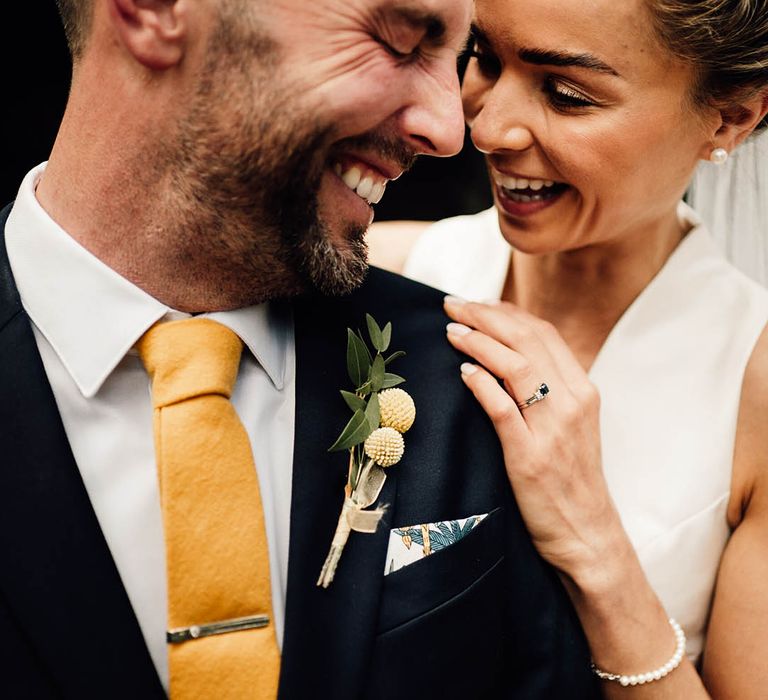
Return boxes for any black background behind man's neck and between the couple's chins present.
[0,0,491,221]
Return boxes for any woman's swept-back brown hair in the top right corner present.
[648,0,768,129]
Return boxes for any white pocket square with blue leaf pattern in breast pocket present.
[384,513,488,576]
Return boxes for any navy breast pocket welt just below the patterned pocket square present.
[379,508,504,633]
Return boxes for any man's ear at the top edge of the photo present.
[108,0,187,70]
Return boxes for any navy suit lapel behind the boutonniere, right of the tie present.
[280,299,396,700]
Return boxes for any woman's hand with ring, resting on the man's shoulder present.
[445,297,630,588]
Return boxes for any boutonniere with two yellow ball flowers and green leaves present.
[317,314,416,588]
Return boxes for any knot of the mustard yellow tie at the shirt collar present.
[136,318,243,408]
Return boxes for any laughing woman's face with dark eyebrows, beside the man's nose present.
[463,0,719,253]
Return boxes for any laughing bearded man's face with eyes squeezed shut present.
[170,0,471,296]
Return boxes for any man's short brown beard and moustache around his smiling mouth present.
[157,7,414,305]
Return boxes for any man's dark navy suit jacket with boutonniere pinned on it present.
[0,209,600,700]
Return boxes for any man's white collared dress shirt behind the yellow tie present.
[6,164,295,688]
